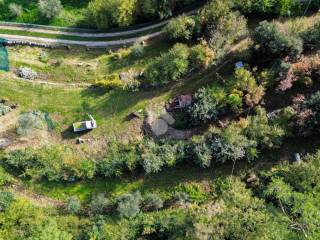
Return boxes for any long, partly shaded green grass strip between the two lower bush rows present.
[24,163,255,202]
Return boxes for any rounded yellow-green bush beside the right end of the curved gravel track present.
[164,16,196,41]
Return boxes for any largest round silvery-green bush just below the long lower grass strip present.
[117,191,141,218]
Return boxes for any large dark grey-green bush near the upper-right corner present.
[252,21,303,59]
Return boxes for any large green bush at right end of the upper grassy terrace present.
[143,44,189,87]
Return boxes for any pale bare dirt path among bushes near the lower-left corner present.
[11,183,65,208]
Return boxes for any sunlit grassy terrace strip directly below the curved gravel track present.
[8,42,170,83]
